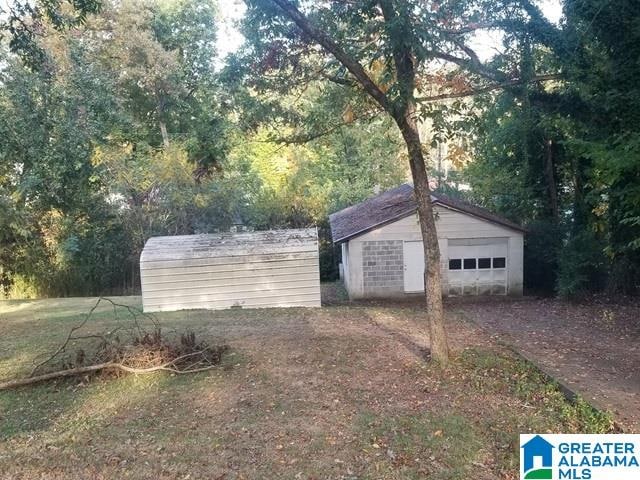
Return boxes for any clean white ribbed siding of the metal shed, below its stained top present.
[140,231,320,312]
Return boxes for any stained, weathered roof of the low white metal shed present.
[140,228,318,263]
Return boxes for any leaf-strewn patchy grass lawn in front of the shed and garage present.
[0,297,611,480]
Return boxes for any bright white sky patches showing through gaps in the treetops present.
[218,0,562,60]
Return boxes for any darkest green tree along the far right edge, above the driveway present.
[558,0,640,293]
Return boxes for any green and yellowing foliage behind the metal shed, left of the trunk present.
[0,0,405,297]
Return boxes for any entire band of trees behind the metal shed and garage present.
[0,0,640,313]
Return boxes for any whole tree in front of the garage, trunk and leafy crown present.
[238,0,556,363]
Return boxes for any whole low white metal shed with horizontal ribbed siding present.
[140,229,320,312]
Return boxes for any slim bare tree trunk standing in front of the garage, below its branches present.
[395,102,449,364]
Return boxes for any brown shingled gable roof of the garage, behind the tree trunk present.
[329,183,524,243]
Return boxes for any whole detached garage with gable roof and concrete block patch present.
[329,184,524,299]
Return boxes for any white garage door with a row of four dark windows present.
[447,238,508,295]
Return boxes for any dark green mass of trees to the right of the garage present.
[466,0,640,296]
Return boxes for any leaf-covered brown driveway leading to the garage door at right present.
[449,298,640,432]
